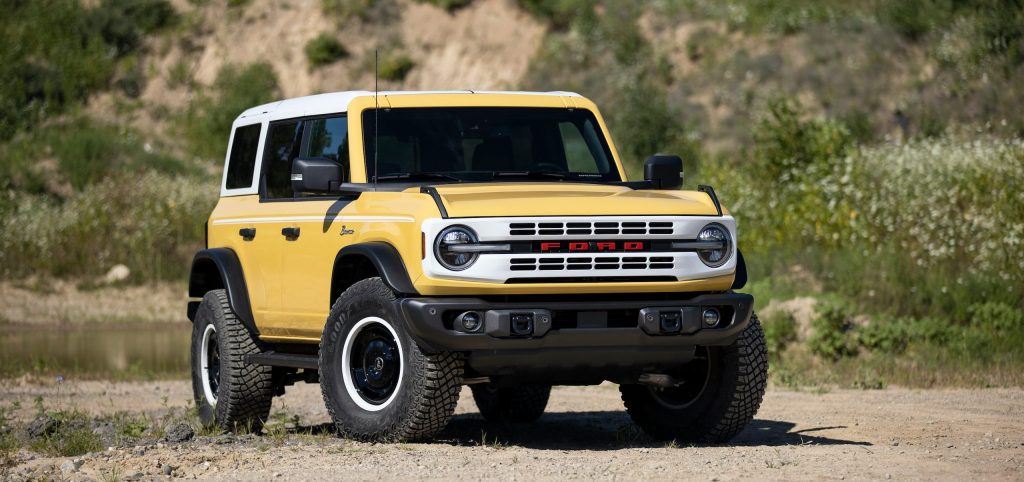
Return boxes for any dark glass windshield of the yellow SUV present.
[362,107,621,182]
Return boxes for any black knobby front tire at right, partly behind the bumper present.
[620,314,768,443]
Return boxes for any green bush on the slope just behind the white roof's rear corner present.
[183,62,281,161]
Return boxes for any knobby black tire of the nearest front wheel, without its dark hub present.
[319,277,463,442]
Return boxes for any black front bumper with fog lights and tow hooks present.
[399,294,754,382]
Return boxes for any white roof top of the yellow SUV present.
[236,90,580,122]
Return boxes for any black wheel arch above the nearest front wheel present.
[328,242,417,305]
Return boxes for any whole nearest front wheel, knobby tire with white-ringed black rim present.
[319,277,463,441]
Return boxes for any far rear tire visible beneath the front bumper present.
[470,384,551,424]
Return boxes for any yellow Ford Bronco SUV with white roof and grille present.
[188,91,768,441]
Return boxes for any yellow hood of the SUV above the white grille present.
[419,182,718,218]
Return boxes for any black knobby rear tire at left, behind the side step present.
[191,290,274,433]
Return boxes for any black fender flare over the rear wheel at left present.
[188,248,259,334]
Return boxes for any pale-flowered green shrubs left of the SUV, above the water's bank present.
[0,172,217,280]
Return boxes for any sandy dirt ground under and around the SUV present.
[0,381,1024,480]
